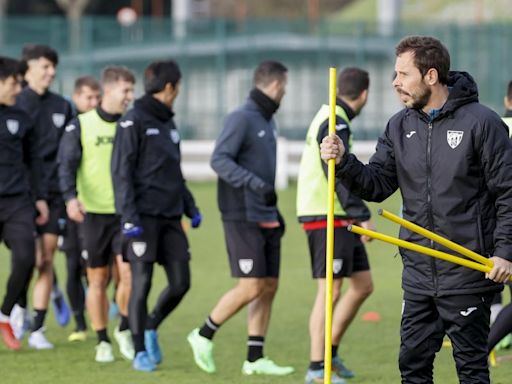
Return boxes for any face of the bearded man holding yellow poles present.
[393,51,432,109]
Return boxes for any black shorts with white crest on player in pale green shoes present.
[223,221,283,278]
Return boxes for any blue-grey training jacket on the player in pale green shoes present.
[210,98,278,223]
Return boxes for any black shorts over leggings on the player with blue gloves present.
[123,215,190,264]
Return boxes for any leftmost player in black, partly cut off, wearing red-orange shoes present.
[0,57,48,349]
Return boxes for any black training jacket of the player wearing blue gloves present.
[112,95,198,224]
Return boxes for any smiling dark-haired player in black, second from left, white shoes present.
[13,44,73,349]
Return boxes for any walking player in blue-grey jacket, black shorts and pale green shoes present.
[188,61,293,375]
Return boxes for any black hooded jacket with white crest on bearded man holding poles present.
[336,72,512,296]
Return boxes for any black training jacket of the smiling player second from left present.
[16,86,73,193]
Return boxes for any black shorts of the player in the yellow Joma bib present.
[79,213,121,268]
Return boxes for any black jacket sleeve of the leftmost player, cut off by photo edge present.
[23,119,48,200]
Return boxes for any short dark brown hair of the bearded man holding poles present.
[395,36,450,84]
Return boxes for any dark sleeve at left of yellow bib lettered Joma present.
[57,119,82,201]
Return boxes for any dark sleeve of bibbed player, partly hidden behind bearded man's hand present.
[317,120,371,221]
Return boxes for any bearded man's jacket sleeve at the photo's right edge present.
[479,115,512,261]
